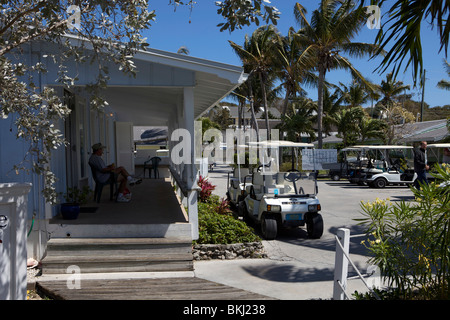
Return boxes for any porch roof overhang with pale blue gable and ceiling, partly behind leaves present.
[41,35,247,126]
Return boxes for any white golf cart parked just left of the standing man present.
[355,145,417,188]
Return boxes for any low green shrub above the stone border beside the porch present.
[195,196,261,244]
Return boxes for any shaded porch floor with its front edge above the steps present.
[47,174,192,238]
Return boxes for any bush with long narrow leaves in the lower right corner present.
[357,165,450,299]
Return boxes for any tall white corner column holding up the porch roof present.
[183,87,198,240]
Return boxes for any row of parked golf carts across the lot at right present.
[323,143,450,188]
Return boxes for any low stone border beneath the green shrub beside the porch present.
[192,242,267,261]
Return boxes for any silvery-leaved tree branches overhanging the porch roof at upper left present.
[0,0,280,203]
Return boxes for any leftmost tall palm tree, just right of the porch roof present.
[229,25,279,139]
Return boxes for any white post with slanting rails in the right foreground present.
[333,228,381,300]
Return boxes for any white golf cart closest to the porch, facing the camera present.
[238,141,323,240]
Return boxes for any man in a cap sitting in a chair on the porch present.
[89,143,142,202]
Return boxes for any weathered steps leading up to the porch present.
[42,238,193,274]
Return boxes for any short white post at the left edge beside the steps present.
[0,183,31,300]
